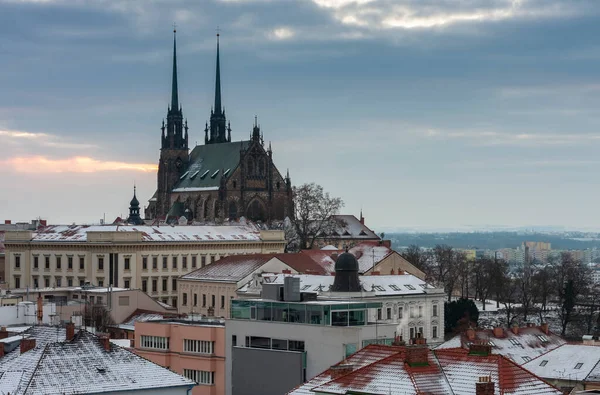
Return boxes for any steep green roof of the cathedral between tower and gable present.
[174,141,250,192]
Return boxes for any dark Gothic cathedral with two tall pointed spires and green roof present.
[145,32,293,222]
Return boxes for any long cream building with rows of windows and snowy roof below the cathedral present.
[5,225,285,307]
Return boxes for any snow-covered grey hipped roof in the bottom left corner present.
[0,328,195,395]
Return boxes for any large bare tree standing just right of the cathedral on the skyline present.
[286,183,344,249]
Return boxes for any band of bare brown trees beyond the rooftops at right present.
[402,244,600,335]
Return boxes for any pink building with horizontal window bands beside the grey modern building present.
[135,319,225,395]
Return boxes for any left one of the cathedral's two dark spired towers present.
[155,30,189,217]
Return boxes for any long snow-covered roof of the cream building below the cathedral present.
[24,224,260,243]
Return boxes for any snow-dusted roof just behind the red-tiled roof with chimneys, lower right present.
[436,326,566,365]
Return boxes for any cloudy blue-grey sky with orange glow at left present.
[0,0,600,228]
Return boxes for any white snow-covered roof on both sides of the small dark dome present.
[238,274,439,296]
